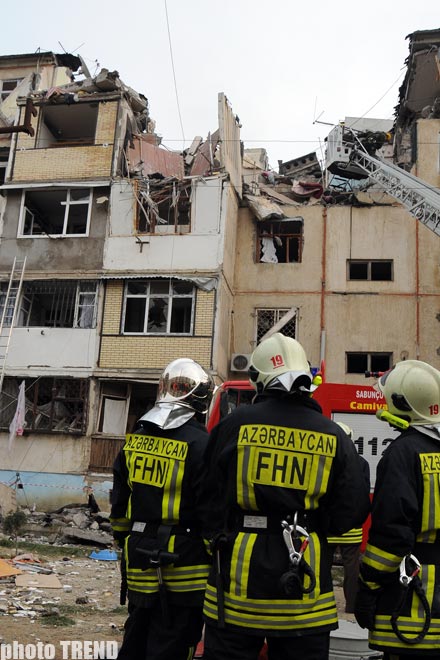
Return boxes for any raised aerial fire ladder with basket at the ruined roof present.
[326,125,440,236]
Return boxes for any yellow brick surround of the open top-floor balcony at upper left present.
[12,101,118,181]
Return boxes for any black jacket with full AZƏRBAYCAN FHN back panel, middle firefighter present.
[204,395,370,635]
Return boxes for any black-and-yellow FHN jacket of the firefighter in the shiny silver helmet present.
[111,418,210,607]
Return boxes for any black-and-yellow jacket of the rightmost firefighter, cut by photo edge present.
[361,427,440,657]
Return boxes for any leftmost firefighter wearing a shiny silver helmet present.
[111,358,214,660]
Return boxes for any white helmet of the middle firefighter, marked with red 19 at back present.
[248,332,316,394]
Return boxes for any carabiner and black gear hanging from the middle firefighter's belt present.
[280,513,316,596]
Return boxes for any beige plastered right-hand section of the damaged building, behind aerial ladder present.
[230,30,440,384]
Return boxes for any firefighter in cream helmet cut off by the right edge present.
[355,360,440,660]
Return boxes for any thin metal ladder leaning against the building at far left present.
[0,257,26,392]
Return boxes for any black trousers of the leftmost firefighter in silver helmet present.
[118,602,203,660]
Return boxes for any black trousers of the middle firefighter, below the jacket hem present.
[203,623,330,660]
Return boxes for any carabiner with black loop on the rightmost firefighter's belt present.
[391,555,431,644]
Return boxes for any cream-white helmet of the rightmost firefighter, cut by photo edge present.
[377,360,440,425]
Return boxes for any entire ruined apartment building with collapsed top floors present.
[0,30,440,506]
